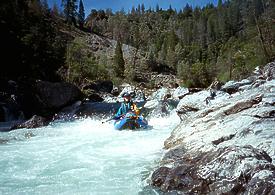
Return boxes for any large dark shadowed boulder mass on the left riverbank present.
[0,79,84,131]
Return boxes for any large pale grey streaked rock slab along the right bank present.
[151,61,275,195]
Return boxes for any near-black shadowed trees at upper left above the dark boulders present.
[0,0,67,80]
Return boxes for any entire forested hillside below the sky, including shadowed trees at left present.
[0,0,275,87]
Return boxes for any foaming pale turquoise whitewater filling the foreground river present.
[0,114,179,195]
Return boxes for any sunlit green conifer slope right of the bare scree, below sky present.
[86,0,275,86]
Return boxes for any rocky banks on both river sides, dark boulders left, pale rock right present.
[0,62,275,194]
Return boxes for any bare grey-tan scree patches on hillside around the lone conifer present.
[82,33,179,87]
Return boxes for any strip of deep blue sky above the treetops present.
[48,0,218,16]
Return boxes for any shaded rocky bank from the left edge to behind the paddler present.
[0,76,170,131]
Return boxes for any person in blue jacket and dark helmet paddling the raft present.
[115,92,140,118]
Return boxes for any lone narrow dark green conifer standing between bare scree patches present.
[114,41,125,78]
